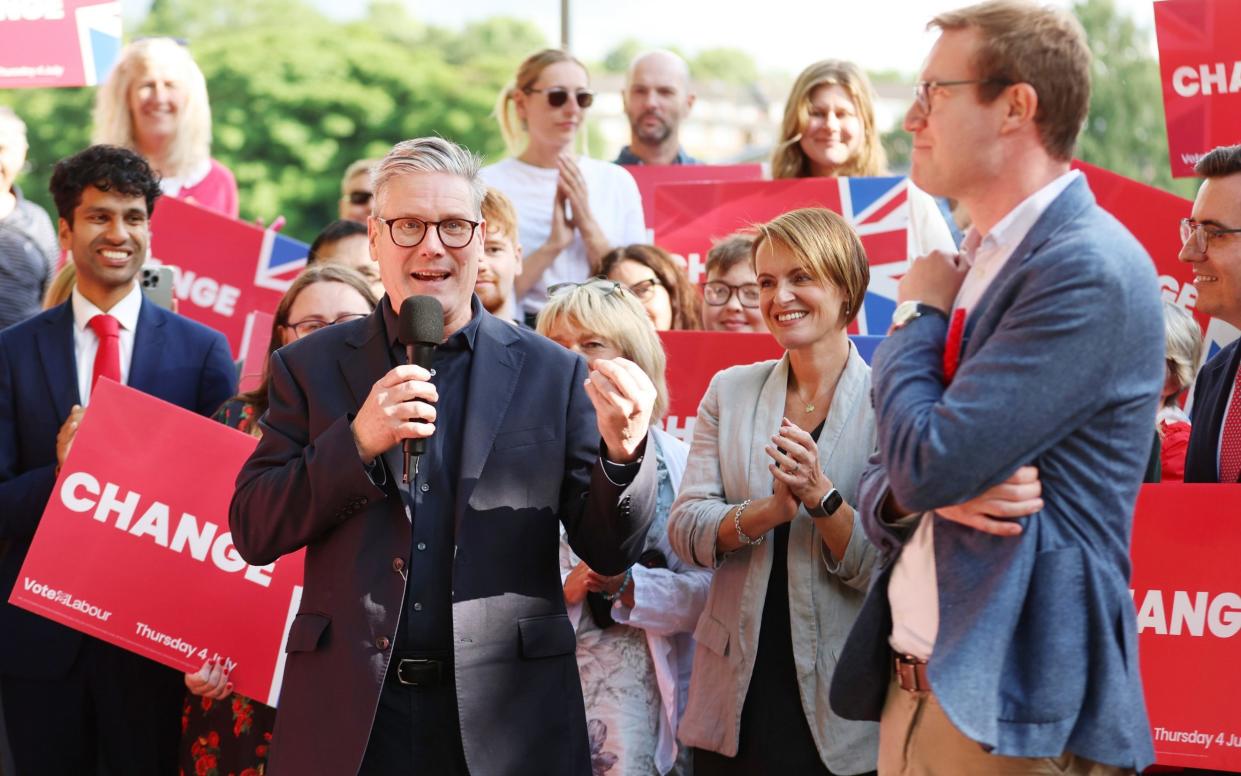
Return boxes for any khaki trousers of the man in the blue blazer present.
[879,678,1133,776]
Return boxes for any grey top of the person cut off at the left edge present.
[0,186,60,329]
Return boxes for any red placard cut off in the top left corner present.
[0,0,120,89]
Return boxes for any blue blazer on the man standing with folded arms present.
[831,179,1164,770]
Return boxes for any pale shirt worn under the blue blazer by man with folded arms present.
[887,170,1081,659]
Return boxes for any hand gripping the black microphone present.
[350,364,439,463]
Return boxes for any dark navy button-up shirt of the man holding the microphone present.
[381,297,483,657]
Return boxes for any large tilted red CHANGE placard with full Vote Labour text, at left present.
[9,380,304,705]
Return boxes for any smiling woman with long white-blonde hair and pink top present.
[92,37,237,219]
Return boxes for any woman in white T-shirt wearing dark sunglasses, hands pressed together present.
[482,48,647,315]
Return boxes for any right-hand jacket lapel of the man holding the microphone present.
[454,312,525,521]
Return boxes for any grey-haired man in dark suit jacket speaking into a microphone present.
[230,138,656,776]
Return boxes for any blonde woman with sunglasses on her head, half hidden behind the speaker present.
[537,278,711,776]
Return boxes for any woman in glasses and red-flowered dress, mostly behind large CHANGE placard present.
[180,264,379,774]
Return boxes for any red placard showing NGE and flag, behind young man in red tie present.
[151,196,309,358]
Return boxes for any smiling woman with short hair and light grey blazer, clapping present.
[668,209,879,776]
